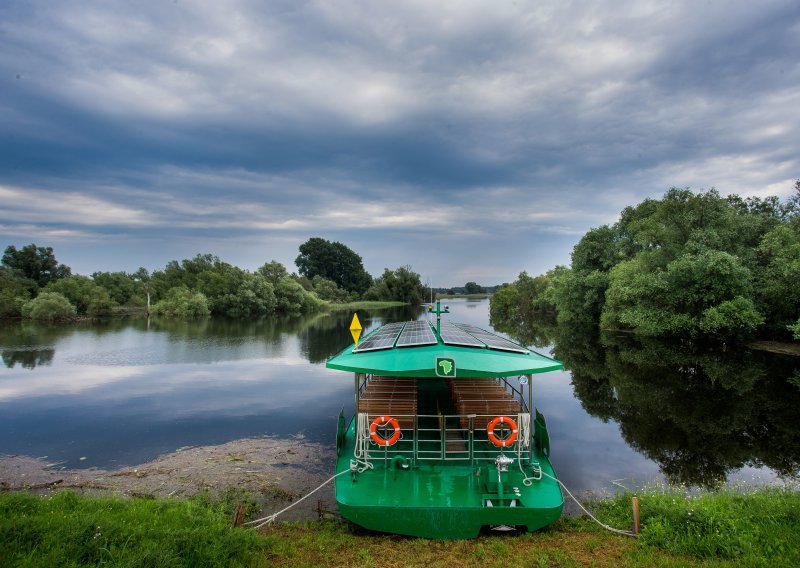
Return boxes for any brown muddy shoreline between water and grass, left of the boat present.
[0,436,338,520]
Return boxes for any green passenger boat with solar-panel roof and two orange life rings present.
[326,302,564,539]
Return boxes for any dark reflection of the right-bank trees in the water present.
[492,321,800,487]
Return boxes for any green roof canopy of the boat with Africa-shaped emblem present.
[325,324,563,378]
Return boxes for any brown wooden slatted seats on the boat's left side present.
[358,377,417,429]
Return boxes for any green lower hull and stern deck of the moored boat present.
[336,423,563,540]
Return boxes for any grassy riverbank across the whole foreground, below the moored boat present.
[0,488,800,567]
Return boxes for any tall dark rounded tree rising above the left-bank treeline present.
[294,237,372,294]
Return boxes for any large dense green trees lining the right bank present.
[491,184,800,339]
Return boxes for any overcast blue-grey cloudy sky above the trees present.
[0,0,800,286]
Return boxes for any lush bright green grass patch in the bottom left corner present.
[0,492,266,568]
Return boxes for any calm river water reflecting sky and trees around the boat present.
[0,300,800,492]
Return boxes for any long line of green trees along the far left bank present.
[0,237,425,321]
